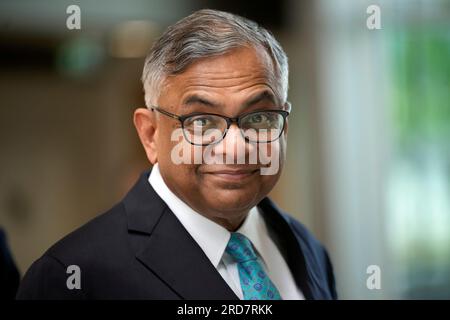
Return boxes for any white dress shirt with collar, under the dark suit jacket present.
[148,164,304,300]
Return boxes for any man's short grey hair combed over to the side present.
[142,9,289,107]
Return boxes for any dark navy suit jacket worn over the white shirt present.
[17,172,336,300]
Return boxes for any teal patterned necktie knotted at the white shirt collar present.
[226,232,281,300]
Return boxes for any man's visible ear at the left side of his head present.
[133,108,158,165]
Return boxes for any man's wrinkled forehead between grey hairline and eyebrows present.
[161,47,275,104]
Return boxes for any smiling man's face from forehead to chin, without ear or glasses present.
[137,48,286,229]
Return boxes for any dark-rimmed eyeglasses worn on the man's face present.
[150,102,291,146]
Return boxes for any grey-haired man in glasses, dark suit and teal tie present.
[18,10,336,300]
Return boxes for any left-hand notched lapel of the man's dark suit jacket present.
[124,172,238,300]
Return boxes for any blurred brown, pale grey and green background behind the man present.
[0,0,450,299]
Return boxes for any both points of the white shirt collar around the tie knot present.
[148,163,268,268]
